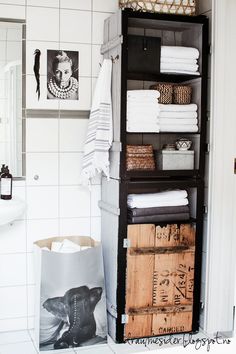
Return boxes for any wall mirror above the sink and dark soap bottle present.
[0,22,23,177]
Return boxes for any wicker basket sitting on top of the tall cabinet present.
[119,0,196,15]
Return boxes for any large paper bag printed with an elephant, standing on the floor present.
[34,236,107,351]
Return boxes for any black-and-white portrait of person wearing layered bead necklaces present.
[47,50,79,100]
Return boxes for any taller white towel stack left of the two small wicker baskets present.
[126,90,160,133]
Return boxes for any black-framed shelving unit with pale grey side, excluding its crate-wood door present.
[100,10,208,342]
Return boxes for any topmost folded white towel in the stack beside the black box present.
[161,46,199,59]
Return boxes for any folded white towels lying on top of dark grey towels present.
[127,189,189,208]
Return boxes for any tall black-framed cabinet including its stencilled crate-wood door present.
[100,10,208,342]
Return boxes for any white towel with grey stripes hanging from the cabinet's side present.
[82,59,113,185]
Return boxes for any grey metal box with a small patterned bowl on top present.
[156,150,194,170]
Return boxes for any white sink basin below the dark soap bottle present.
[0,198,25,225]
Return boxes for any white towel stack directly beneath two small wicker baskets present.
[159,103,198,133]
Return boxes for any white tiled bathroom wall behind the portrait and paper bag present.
[0,0,118,331]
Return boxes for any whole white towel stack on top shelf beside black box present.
[161,46,200,75]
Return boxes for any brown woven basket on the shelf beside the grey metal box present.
[126,145,155,171]
